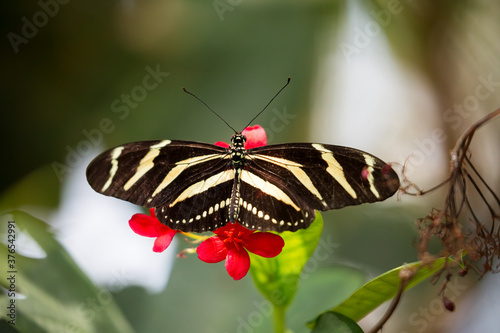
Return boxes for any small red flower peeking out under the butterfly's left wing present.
[128,208,178,252]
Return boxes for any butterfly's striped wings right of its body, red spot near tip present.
[236,143,399,231]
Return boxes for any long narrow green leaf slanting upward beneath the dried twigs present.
[310,258,451,325]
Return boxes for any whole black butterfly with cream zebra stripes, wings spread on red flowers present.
[87,79,399,232]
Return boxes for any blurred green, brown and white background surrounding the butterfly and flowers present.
[0,0,500,333]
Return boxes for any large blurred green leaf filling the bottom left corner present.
[0,211,133,333]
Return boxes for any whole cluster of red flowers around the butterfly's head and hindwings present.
[129,125,285,280]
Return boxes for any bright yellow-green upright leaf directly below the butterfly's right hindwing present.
[250,213,323,309]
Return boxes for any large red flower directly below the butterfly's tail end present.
[196,223,285,280]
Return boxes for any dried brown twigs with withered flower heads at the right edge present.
[412,109,500,276]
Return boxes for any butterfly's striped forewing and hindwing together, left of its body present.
[87,140,234,231]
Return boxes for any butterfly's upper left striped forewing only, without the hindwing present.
[87,140,228,207]
